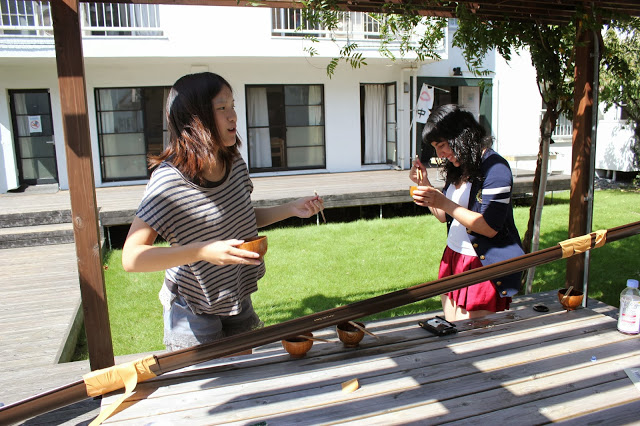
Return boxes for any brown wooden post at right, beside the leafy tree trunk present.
[565,25,597,290]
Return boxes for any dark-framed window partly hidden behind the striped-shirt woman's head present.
[96,87,169,182]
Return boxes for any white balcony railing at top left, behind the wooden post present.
[0,0,163,37]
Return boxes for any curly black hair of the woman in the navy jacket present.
[422,104,493,184]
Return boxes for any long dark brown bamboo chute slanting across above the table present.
[0,222,640,424]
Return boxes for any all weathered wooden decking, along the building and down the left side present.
[0,169,569,424]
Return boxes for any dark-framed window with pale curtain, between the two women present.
[246,85,325,172]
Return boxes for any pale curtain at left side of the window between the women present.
[247,87,272,167]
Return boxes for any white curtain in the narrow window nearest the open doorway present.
[364,84,387,164]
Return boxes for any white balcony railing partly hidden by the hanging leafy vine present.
[271,8,446,50]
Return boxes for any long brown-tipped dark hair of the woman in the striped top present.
[149,72,241,185]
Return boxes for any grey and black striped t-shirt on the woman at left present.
[136,156,265,315]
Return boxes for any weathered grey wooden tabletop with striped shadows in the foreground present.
[81,292,640,425]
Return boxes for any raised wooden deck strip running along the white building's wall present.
[0,168,571,226]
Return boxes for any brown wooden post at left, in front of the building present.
[50,0,114,370]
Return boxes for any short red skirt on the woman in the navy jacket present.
[438,246,511,312]
